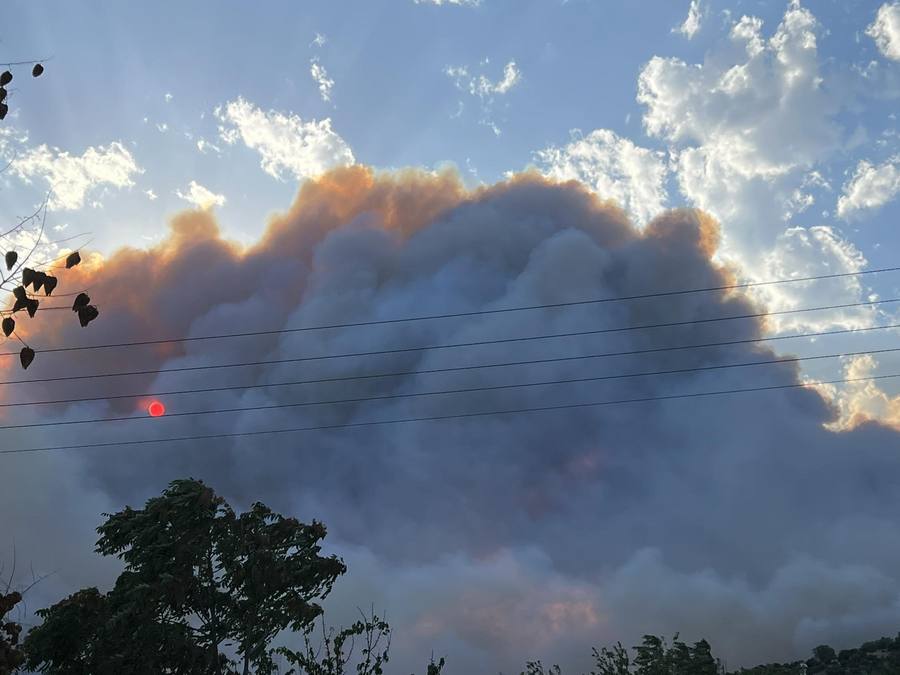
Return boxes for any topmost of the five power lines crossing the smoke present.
[0,267,900,356]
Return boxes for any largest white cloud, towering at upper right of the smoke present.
[638,3,841,260]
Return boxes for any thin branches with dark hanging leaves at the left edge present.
[0,61,100,369]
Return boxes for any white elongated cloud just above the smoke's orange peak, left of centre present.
[215,97,355,180]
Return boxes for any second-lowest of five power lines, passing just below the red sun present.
[0,347,900,430]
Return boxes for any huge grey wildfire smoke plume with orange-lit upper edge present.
[7,166,900,672]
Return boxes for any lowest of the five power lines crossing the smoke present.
[0,373,900,455]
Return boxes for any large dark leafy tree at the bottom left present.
[25,480,346,675]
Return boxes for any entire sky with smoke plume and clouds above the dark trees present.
[0,0,900,673]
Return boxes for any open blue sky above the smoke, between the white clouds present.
[3,0,897,256]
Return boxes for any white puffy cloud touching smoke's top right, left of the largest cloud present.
[535,129,667,223]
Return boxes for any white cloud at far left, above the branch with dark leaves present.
[10,141,143,210]
